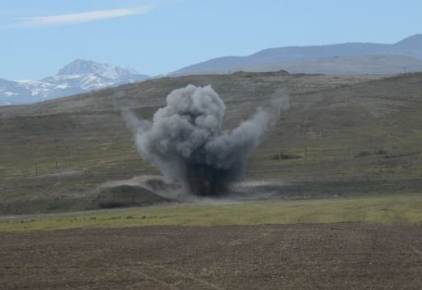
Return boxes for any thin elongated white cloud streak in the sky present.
[9,6,152,28]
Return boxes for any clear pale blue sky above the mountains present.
[0,0,422,80]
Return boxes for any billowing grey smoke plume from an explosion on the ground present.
[125,85,288,196]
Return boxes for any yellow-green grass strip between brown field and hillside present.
[0,194,422,232]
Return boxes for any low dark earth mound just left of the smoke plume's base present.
[91,185,170,208]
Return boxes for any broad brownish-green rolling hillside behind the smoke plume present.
[0,72,422,215]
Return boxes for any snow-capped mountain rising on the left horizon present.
[0,59,149,105]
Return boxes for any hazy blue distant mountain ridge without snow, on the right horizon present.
[170,34,422,75]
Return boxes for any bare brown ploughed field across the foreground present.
[0,224,422,290]
